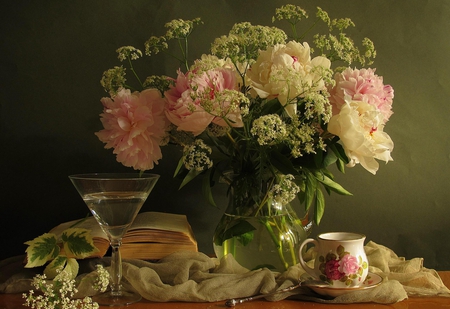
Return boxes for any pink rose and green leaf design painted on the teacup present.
[319,245,369,286]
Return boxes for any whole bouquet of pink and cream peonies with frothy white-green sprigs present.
[96,5,394,255]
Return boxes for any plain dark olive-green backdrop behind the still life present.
[0,0,450,269]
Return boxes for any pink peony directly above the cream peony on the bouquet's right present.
[329,68,394,123]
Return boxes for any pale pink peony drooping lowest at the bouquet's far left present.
[95,89,169,171]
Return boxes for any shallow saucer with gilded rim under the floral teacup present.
[301,272,383,297]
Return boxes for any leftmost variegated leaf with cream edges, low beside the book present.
[25,233,59,268]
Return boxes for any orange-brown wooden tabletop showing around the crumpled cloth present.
[0,271,450,309]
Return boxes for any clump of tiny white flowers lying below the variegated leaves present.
[22,271,99,309]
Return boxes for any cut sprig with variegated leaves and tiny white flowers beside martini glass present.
[23,222,109,309]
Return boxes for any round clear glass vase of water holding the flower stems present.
[213,174,309,272]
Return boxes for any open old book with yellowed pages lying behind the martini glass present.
[50,212,198,260]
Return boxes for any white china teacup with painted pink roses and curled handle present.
[299,232,369,288]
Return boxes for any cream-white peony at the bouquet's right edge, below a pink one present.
[328,98,394,174]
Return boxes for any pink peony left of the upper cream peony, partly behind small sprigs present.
[165,68,242,135]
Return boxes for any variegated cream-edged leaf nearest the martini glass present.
[61,228,98,259]
